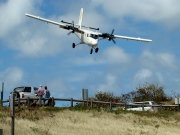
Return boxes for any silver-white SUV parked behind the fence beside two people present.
[11,86,55,105]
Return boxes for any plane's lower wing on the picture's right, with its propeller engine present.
[98,29,152,43]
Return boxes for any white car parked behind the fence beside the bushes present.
[124,101,158,111]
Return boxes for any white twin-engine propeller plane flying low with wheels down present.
[25,8,152,54]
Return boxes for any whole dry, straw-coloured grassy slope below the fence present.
[0,106,180,135]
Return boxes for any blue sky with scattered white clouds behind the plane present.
[0,0,180,101]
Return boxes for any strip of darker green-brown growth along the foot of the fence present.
[0,104,180,121]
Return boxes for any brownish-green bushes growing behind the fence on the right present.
[91,83,174,104]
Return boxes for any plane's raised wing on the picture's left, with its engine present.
[25,14,84,33]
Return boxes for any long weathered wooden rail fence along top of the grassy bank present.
[2,97,180,111]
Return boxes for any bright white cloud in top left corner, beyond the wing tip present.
[0,0,39,37]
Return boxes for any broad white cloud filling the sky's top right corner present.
[92,0,180,27]
